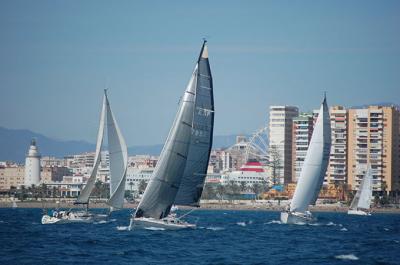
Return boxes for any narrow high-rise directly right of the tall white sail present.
[325,106,348,184]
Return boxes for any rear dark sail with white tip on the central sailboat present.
[174,42,214,206]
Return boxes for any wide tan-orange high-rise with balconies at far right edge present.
[347,106,400,193]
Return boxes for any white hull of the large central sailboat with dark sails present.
[129,217,196,230]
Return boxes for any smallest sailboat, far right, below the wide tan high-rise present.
[347,166,373,215]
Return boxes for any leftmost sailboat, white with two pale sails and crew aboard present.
[42,90,128,224]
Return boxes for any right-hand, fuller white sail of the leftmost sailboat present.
[104,92,128,208]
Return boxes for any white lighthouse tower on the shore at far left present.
[24,139,40,187]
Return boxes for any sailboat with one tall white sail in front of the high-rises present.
[281,96,331,224]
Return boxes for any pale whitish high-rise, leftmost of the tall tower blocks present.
[269,106,299,184]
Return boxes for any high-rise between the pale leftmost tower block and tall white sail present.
[292,113,314,182]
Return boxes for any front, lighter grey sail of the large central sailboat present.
[135,46,206,219]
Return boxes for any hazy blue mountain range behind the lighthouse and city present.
[0,127,244,163]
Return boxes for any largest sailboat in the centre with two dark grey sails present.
[129,41,214,230]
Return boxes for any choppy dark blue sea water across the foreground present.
[0,209,400,265]
